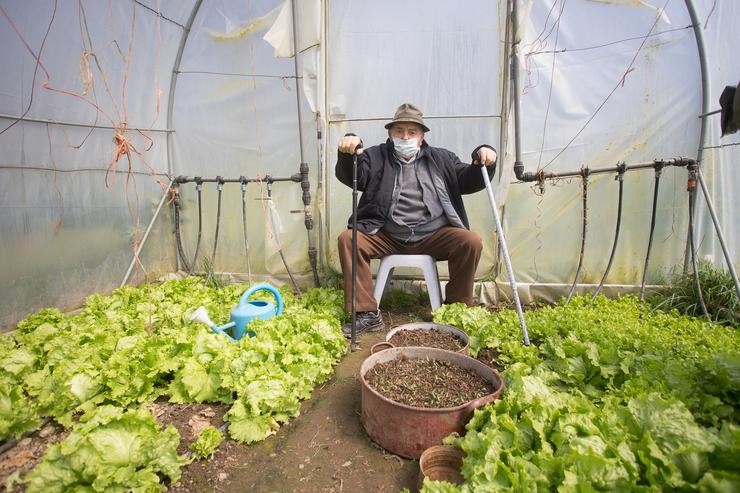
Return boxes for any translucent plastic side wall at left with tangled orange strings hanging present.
[0,0,191,327]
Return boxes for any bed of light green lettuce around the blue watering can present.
[0,277,347,491]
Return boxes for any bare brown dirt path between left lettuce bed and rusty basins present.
[170,320,419,492]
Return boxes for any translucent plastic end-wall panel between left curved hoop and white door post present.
[172,0,321,284]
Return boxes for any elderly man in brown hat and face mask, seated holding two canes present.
[335,103,496,337]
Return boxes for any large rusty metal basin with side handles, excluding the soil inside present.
[360,346,504,459]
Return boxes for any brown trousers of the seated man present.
[339,226,483,312]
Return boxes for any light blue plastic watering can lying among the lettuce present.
[190,283,283,341]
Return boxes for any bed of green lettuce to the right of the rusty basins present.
[423,296,740,492]
